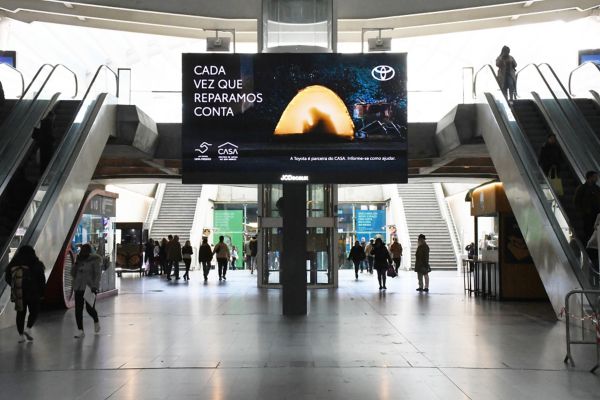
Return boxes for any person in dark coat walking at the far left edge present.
[4,245,46,343]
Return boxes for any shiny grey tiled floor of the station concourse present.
[0,271,600,400]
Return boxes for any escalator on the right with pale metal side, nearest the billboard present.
[474,65,596,315]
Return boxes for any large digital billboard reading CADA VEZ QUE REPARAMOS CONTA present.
[182,53,407,184]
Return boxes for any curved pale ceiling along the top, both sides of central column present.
[0,0,600,42]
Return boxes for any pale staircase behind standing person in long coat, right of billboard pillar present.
[398,183,456,270]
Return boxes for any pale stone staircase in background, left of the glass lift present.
[150,183,202,246]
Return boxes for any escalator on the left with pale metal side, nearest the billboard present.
[0,66,117,307]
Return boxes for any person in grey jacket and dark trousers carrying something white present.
[71,243,102,339]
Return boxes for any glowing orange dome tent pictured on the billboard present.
[275,85,354,140]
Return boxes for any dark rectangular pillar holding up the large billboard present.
[280,183,307,315]
